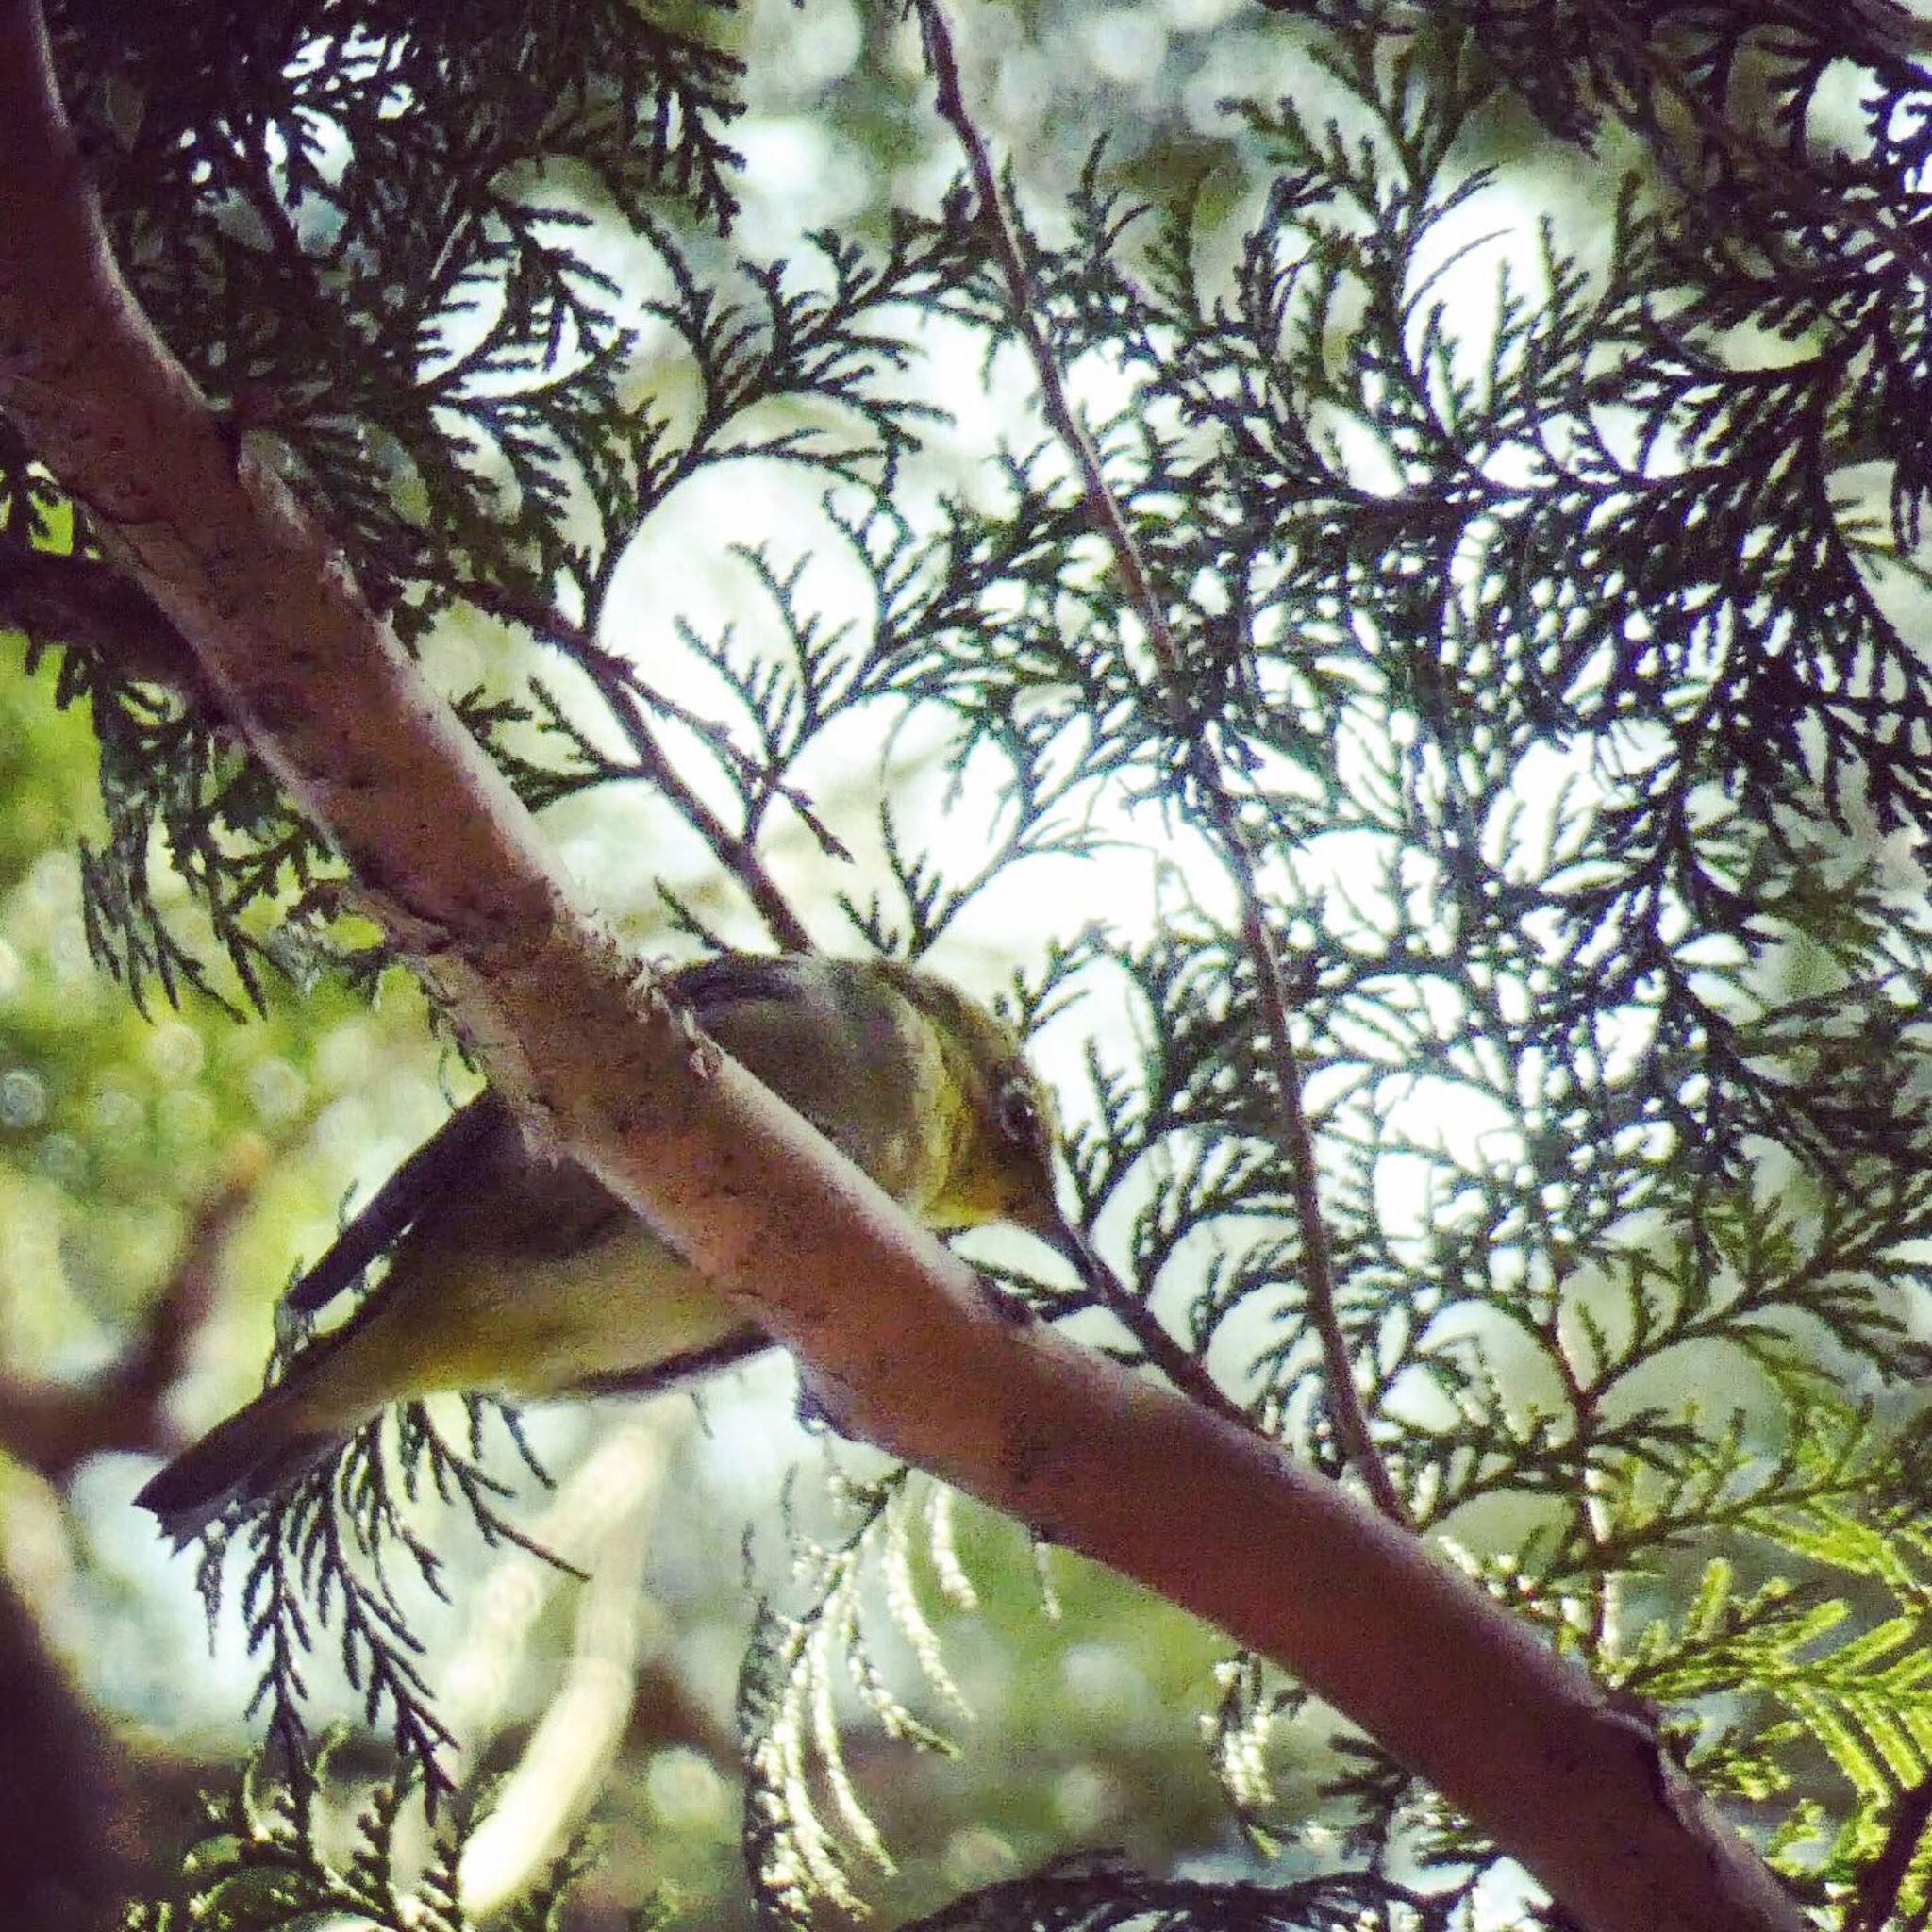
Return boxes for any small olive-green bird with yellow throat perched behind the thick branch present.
[137,955,1090,1541]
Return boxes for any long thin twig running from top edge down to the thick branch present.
[914,0,1410,1524]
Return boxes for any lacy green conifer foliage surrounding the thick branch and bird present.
[11,0,1932,1932]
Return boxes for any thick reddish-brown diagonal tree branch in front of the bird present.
[0,0,1801,1932]
